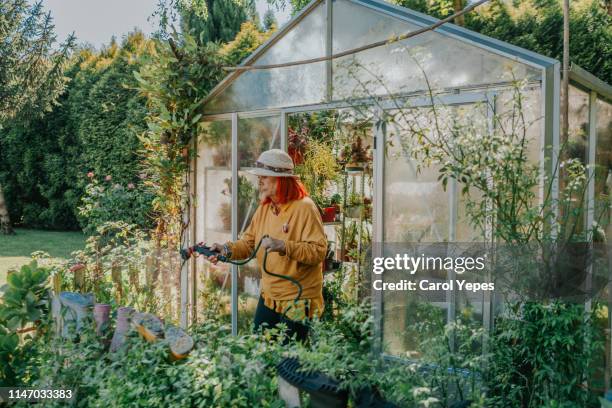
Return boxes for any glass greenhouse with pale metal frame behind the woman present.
[186,0,612,373]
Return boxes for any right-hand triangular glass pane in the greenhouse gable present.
[332,0,541,100]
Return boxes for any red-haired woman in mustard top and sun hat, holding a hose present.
[208,149,327,340]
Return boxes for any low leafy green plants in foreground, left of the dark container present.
[10,308,284,407]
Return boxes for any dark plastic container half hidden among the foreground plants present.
[276,358,348,408]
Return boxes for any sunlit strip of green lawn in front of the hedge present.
[0,229,85,285]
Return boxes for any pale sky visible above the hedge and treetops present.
[43,0,289,48]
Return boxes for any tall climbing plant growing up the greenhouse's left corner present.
[134,17,272,322]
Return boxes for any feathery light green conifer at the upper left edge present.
[0,0,74,234]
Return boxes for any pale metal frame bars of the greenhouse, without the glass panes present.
[181,0,612,380]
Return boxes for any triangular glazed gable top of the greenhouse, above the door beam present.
[204,0,610,115]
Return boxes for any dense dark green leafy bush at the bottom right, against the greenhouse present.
[486,301,603,407]
